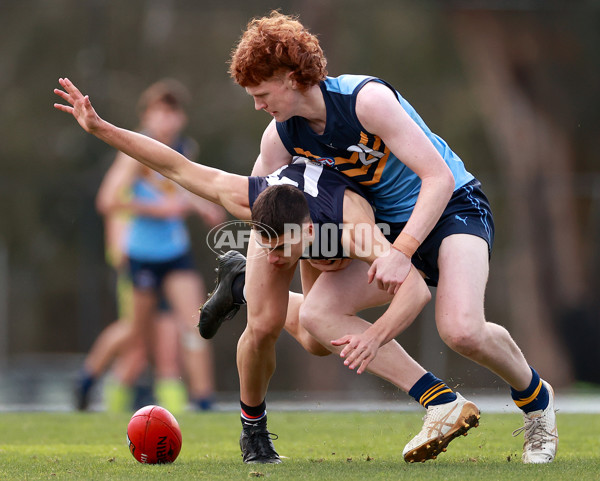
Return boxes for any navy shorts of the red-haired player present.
[378,179,494,286]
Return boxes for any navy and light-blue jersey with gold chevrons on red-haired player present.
[277,75,473,222]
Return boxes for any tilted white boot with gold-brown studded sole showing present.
[402,393,479,463]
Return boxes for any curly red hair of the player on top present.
[229,11,327,89]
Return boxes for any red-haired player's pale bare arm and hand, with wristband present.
[356,82,454,291]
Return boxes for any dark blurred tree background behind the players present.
[0,0,600,394]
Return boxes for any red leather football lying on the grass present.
[127,406,181,464]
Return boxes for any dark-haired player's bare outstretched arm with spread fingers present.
[54,78,251,220]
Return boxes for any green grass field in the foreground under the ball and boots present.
[0,411,600,481]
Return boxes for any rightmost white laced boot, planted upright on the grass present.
[513,380,558,464]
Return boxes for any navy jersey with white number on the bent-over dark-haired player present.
[248,158,364,259]
